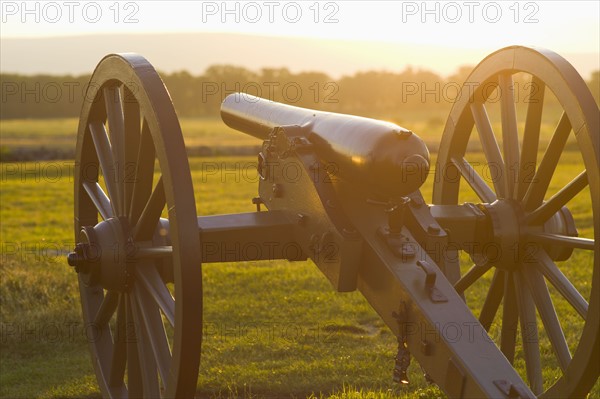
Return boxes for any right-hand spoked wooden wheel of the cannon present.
[433,46,600,398]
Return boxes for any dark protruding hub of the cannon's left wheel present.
[67,218,135,292]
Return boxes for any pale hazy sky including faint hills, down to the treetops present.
[0,0,600,78]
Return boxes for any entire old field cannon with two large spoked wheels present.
[68,46,600,398]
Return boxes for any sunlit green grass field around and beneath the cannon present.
[0,115,600,398]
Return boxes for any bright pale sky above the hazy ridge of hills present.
[1,0,600,52]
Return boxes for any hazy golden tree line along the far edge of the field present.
[0,65,600,119]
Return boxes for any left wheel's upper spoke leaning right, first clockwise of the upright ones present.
[129,120,156,226]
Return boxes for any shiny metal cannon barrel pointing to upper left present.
[221,93,429,200]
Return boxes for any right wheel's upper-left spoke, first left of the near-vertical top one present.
[471,103,506,198]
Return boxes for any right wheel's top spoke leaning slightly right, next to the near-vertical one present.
[517,76,546,200]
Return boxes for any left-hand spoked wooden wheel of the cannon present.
[69,54,202,398]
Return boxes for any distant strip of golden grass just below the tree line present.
[0,104,575,161]
